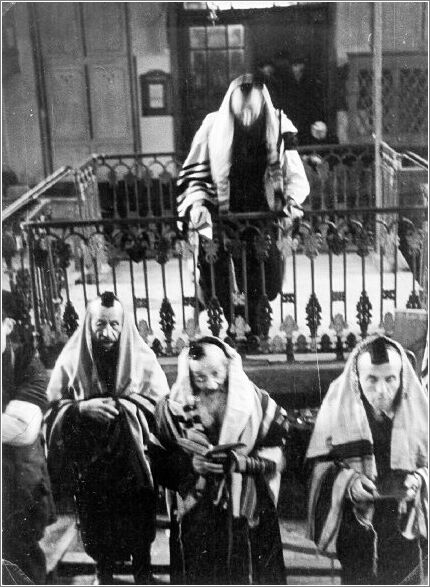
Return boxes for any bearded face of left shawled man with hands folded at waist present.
[90,300,124,350]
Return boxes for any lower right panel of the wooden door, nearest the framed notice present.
[89,58,131,141]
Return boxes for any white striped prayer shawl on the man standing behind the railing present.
[178,76,310,217]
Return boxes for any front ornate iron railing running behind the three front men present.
[24,206,426,362]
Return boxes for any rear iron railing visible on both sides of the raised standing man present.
[95,145,374,218]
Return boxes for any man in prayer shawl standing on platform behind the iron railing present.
[177,74,309,335]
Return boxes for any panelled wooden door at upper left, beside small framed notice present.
[36,2,134,169]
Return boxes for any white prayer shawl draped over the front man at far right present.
[306,337,428,552]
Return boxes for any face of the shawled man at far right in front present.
[357,349,402,419]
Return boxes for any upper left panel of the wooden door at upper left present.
[37,2,83,59]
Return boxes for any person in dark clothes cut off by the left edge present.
[1,291,55,585]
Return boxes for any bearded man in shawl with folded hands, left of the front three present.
[47,292,168,584]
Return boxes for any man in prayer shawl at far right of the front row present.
[307,336,428,585]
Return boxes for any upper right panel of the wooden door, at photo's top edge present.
[83,2,127,56]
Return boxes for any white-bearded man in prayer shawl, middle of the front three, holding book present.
[158,336,288,585]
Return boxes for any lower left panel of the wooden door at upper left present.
[47,65,90,142]
